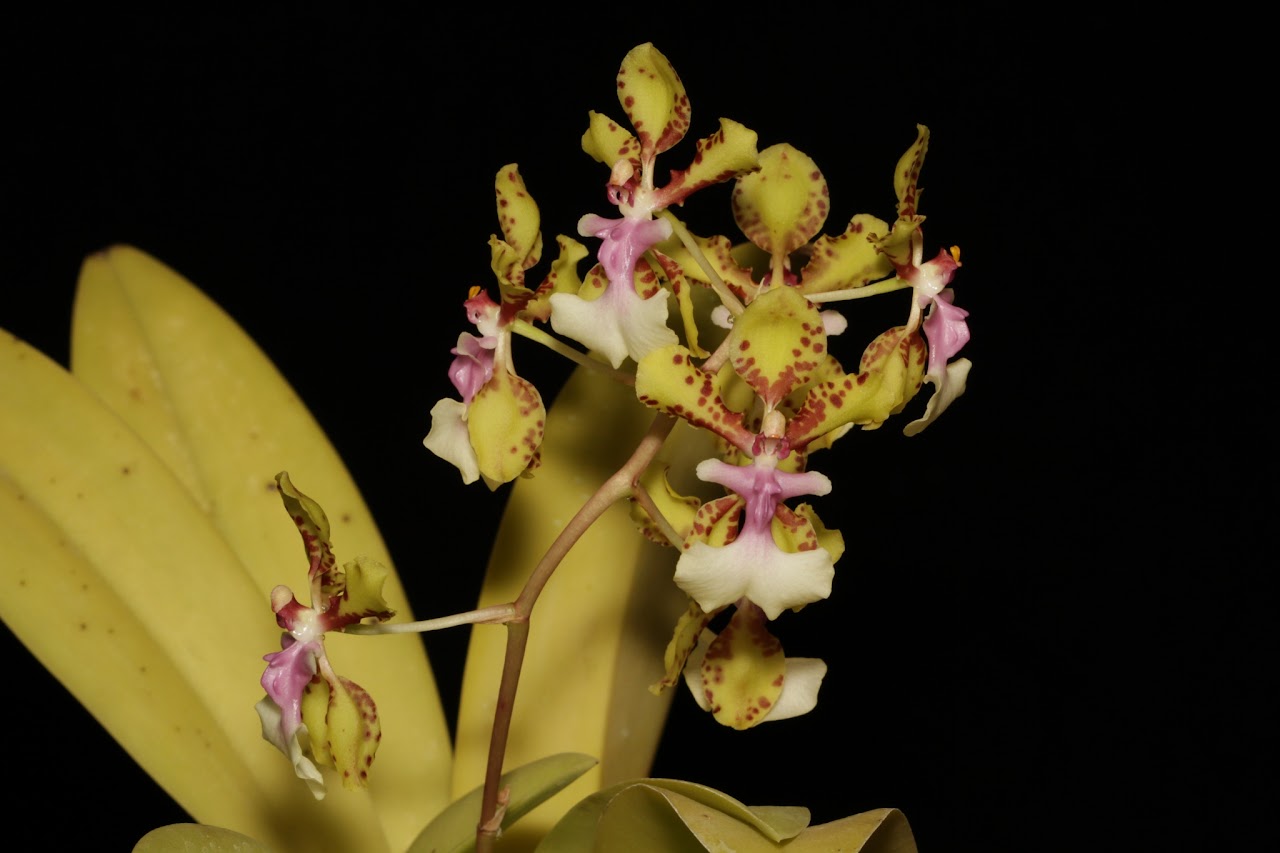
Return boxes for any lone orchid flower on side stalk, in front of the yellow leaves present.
[256,473,394,799]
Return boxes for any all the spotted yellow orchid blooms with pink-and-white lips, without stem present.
[260,44,969,829]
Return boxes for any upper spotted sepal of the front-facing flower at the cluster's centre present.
[728,286,827,407]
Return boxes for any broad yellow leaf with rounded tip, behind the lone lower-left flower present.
[72,246,451,848]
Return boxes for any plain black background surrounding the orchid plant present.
[0,6,1262,850]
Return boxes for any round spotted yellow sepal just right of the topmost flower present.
[733,142,828,257]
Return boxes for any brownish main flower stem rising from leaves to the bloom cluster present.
[476,415,676,853]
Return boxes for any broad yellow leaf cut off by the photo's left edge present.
[0,327,387,850]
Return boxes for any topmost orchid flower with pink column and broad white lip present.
[549,44,756,368]
